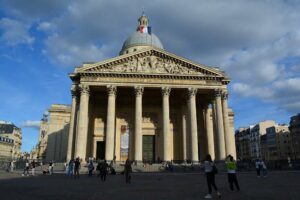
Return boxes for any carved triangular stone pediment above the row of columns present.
[75,47,225,77]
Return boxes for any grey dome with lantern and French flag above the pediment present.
[120,15,163,55]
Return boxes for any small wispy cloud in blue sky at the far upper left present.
[0,18,34,46]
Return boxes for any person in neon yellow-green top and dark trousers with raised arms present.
[226,155,240,191]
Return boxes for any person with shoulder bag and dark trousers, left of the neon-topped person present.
[204,154,221,199]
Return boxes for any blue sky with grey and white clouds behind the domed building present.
[0,0,300,151]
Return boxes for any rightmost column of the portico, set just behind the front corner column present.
[222,91,236,158]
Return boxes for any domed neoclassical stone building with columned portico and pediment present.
[67,15,236,162]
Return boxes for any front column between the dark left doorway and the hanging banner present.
[105,85,117,160]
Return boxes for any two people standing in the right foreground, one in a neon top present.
[204,154,240,199]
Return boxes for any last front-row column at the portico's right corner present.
[215,90,226,160]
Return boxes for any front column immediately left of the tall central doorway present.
[134,87,144,161]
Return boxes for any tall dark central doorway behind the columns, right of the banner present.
[143,135,155,162]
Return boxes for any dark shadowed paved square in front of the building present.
[0,171,300,200]
